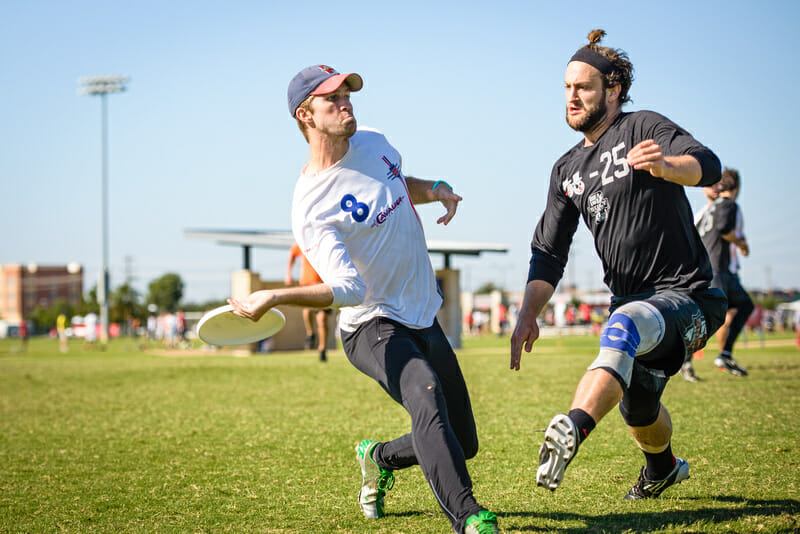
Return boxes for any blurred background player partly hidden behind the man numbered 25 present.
[684,169,754,376]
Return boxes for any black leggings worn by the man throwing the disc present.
[342,317,484,532]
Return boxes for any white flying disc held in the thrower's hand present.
[197,304,286,346]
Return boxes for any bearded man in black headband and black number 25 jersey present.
[511,30,726,499]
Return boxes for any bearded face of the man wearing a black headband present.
[564,61,608,132]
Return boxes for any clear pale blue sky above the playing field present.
[0,0,800,302]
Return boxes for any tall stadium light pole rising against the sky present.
[78,76,129,343]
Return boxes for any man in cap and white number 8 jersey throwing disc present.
[229,65,499,534]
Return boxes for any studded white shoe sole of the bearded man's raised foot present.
[536,415,578,491]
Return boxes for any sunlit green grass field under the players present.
[0,336,800,533]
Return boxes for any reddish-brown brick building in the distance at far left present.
[0,263,83,324]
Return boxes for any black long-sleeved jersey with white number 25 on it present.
[528,111,720,297]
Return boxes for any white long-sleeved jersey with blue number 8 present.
[292,128,442,331]
